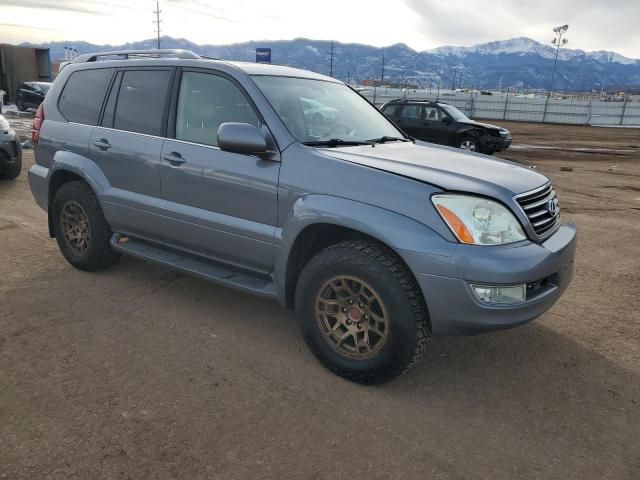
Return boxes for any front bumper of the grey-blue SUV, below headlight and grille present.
[401,224,576,335]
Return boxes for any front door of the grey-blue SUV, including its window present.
[161,69,280,273]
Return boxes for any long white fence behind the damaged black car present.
[361,87,640,127]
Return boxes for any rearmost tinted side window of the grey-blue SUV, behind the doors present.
[58,68,113,125]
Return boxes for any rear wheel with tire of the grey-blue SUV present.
[52,181,120,272]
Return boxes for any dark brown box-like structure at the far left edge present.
[0,44,51,103]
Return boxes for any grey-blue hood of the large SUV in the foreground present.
[319,141,548,198]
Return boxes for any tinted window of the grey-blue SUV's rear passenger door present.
[113,70,172,136]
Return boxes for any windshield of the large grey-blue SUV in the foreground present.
[253,75,404,145]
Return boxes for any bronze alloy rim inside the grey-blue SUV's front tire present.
[315,276,389,359]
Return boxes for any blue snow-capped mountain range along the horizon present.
[25,36,640,91]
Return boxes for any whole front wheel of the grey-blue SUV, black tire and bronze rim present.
[295,240,431,384]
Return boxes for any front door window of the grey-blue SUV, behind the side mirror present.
[176,72,260,145]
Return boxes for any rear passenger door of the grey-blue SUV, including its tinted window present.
[89,67,175,240]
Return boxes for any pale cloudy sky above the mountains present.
[0,0,640,58]
